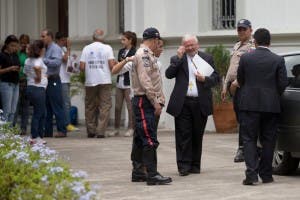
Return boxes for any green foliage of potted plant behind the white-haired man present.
[205,44,230,104]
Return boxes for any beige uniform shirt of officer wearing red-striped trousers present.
[131,44,165,105]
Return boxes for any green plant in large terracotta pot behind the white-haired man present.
[205,45,237,133]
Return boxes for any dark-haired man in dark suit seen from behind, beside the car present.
[237,28,288,185]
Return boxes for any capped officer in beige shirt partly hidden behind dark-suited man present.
[221,19,254,162]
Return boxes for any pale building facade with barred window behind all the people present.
[0,0,300,131]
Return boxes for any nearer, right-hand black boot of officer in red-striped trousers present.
[143,146,172,185]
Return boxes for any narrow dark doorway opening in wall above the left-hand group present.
[57,0,69,36]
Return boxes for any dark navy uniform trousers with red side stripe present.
[131,95,159,177]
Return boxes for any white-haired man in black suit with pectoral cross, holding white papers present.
[166,35,219,176]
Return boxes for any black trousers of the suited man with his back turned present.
[240,111,279,181]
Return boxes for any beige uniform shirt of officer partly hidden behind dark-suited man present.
[223,40,254,89]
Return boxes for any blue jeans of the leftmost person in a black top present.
[0,82,19,123]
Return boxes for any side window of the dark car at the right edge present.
[284,54,300,88]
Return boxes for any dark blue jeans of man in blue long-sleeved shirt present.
[45,77,67,137]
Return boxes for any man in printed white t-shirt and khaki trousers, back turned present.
[80,29,116,138]
